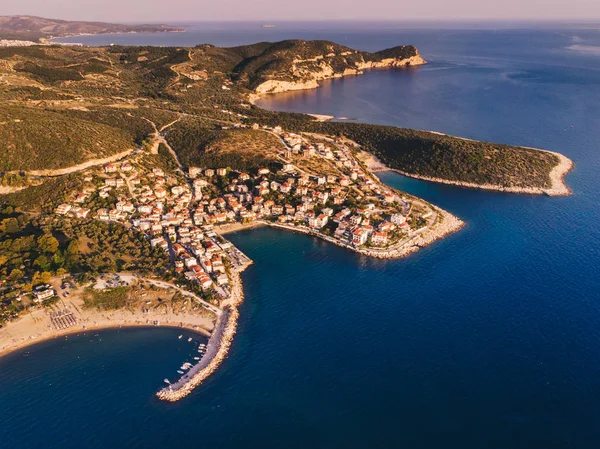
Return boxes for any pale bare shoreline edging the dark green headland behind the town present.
[362,150,575,196]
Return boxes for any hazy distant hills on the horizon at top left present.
[0,16,182,41]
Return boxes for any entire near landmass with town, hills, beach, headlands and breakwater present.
[0,40,572,401]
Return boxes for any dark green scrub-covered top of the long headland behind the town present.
[284,123,559,188]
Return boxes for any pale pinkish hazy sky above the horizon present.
[0,0,600,23]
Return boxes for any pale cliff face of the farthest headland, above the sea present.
[255,47,427,94]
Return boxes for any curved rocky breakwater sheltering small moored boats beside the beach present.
[156,272,244,402]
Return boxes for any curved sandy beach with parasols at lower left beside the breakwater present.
[0,300,214,356]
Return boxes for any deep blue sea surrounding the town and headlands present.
[0,23,600,449]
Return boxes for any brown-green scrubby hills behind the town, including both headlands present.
[0,40,568,188]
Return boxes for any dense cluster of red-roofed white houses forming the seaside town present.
[55,123,446,303]
